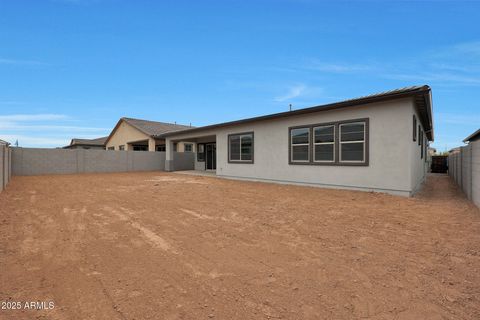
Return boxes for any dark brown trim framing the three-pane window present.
[287,118,370,167]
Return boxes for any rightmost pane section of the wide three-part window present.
[339,122,366,163]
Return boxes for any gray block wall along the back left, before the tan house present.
[12,148,165,175]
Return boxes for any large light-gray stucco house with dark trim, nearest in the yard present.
[159,85,433,196]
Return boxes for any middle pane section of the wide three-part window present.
[313,125,335,162]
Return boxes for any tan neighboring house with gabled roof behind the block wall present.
[105,117,195,152]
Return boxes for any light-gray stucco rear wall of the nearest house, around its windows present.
[167,99,423,196]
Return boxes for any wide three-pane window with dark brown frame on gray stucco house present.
[289,118,368,166]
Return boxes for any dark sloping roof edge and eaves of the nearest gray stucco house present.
[162,85,433,141]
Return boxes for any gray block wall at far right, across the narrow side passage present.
[448,140,480,207]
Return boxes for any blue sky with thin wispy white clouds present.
[0,0,480,151]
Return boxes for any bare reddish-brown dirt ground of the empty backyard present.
[0,172,480,319]
